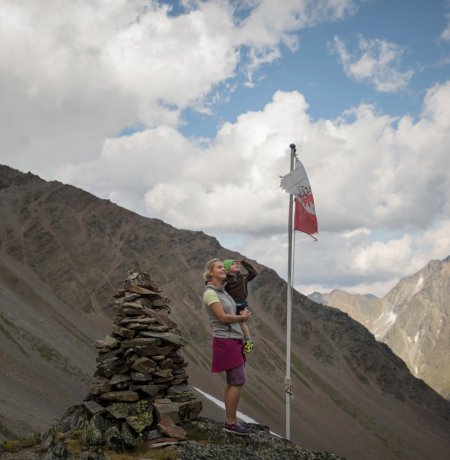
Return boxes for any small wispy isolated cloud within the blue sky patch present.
[331,36,414,93]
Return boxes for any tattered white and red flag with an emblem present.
[280,158,318,235]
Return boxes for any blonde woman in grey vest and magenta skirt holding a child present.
[203,259,252,435]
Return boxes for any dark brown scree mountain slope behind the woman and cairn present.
[0,166,450,459]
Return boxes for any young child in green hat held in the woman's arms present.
[223,258,257,354]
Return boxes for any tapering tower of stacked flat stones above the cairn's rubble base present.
[91,273,201,433]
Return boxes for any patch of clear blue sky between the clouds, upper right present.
[176,0,450,137]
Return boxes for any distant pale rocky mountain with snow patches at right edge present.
[316,257,450,399]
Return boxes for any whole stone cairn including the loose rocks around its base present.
[42,273,202,458]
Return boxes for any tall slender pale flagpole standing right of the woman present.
[284,144,296,440]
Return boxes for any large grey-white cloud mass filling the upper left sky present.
[0,0,354,177]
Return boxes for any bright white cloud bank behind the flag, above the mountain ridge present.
[55,82,450,295]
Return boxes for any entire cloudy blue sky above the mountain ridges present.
[0,0,450,296]
